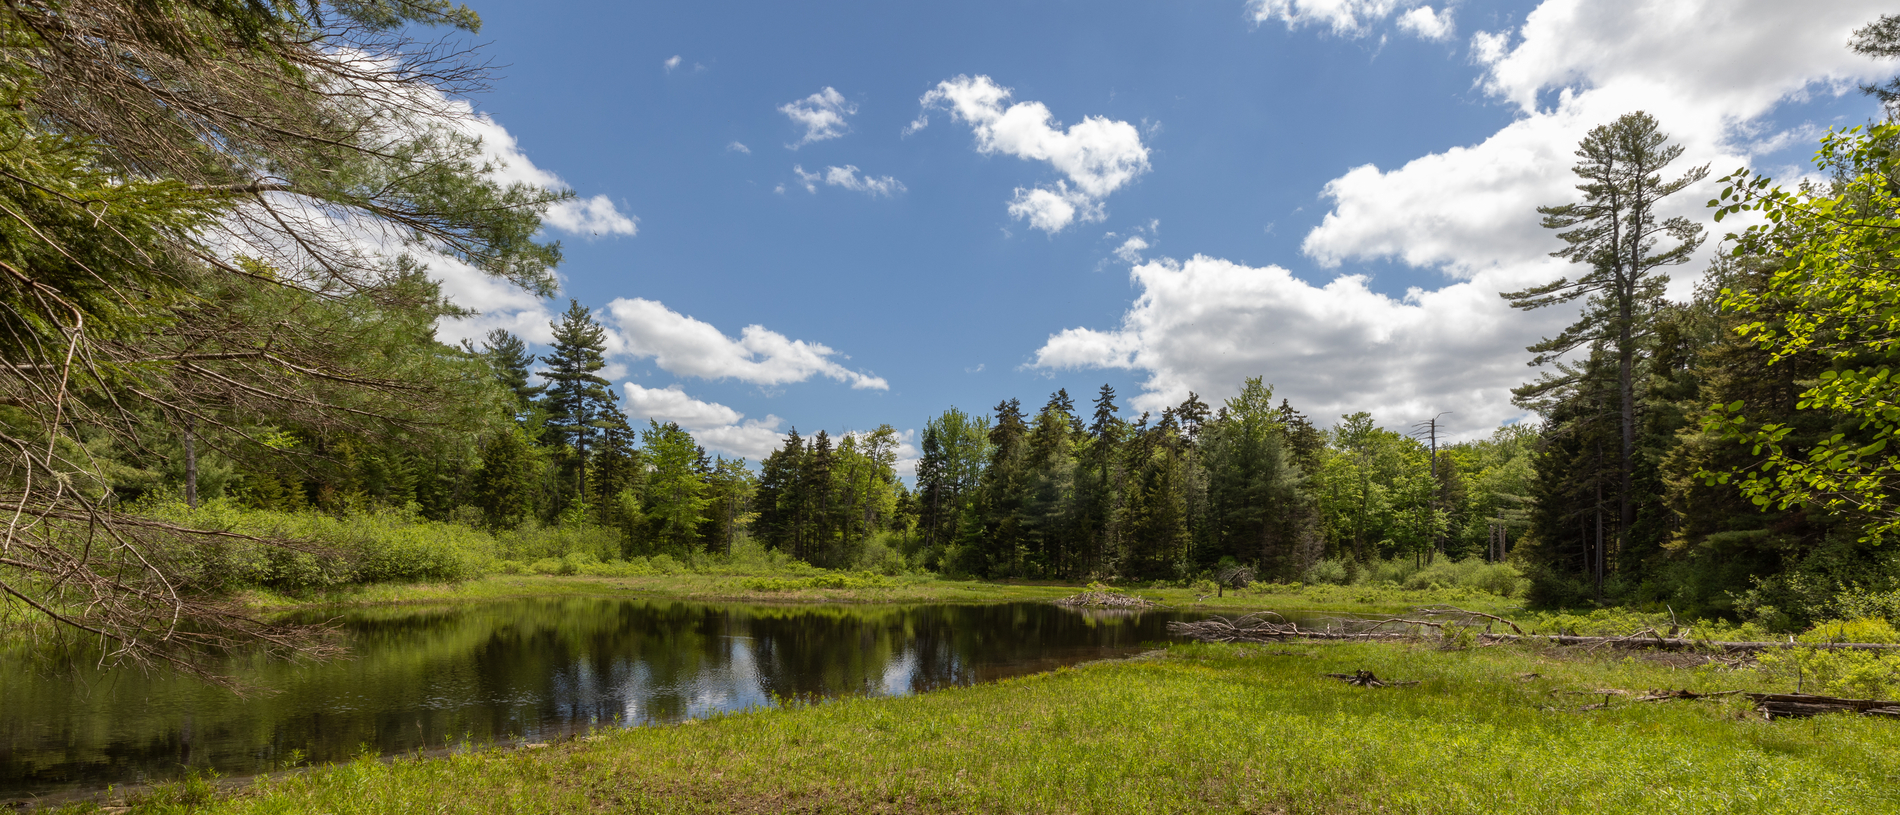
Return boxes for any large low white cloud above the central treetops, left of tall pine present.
[1034,256,1566,435]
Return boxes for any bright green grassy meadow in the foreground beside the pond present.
[104,642,1900,815]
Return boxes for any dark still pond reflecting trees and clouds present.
[0,598,1231,800]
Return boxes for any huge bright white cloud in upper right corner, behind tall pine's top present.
[1303,0,1891,277]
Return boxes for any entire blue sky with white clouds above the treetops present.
[431,0,1892,467]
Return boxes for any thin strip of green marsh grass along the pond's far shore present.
[241,572,1516,614]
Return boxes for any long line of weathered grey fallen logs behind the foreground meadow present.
[1169,608,1900,654]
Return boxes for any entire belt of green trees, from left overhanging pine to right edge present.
[11,0,1900,665]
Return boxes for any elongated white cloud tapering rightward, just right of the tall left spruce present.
[602,298,891,389]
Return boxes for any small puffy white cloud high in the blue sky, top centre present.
[906,76,1150,232]
